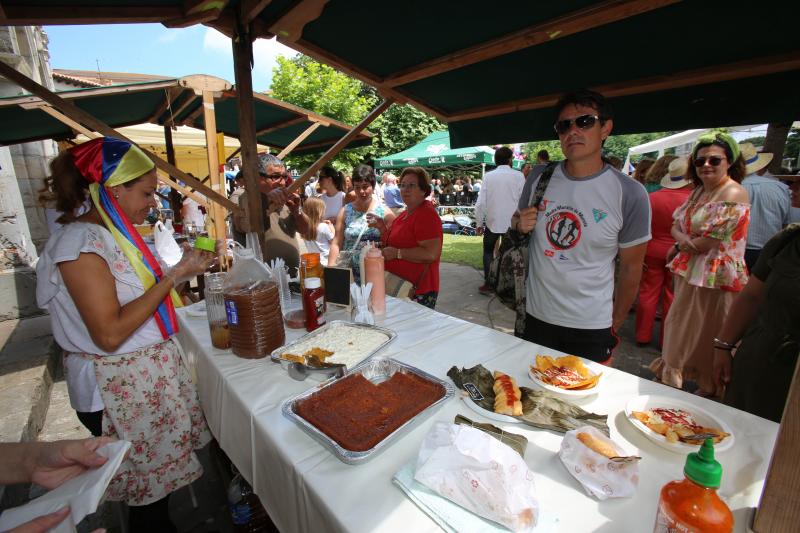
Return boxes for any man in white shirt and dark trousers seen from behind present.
[475,146,525,295]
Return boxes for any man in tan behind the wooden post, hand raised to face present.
[234,154,308,276]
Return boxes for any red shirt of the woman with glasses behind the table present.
[386,200,442,294]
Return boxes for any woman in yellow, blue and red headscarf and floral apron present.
[36,137,214,531]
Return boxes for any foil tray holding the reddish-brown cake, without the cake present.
[281,357,455,465]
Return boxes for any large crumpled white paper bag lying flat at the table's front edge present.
[414,422,539,532]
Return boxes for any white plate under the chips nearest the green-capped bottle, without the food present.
[625,395,734,453]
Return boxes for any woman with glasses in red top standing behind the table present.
[375,167,442,309]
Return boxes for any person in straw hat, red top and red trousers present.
[636,157,693,346]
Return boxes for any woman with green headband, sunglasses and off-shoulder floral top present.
[650,131,750,396]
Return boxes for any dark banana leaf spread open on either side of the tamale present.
[447,365,609,435]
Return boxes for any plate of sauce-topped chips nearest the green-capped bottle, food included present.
[625,396,734,453]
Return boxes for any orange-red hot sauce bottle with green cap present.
[653,439,733,533]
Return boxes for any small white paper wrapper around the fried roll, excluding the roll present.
[558,426,639,500]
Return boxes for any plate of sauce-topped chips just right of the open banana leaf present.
[528,354,604,398]
